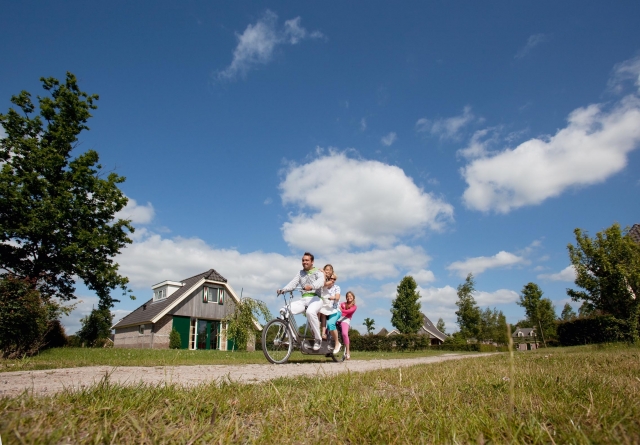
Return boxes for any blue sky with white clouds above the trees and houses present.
[0,1,640,333]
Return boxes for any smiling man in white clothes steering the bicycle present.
[278,252,325,351]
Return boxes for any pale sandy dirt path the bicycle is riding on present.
[0,353,492,397]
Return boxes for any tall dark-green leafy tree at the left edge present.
[0,73,133,309]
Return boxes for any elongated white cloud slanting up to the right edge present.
[461,91,640,213]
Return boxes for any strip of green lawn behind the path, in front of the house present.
[0,348,460,372]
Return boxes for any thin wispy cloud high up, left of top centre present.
[217,10,324,80]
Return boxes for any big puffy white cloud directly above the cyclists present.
[280,153,453,252]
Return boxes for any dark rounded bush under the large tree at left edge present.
[0,274,62,358]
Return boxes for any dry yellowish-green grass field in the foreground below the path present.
[0,345,640,444]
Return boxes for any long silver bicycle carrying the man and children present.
[262,289,345,365]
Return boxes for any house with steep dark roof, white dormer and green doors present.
[113,269,240,351]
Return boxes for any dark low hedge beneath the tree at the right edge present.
[557,315,637,346]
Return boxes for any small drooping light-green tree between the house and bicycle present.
[223,297,273,350]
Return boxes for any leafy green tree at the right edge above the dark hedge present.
[567,223,640,341]
